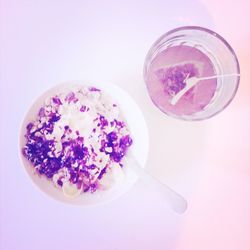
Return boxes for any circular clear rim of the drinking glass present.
[143,26,240,121]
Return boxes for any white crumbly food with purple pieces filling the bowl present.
[22,86,132,197]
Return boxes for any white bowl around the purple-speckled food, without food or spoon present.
[19,81,149,205]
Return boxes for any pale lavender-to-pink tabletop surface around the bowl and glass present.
[0,0,250,250]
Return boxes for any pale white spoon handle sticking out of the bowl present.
[130,157,187,214]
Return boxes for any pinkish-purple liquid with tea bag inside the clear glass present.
[146,45,217,116]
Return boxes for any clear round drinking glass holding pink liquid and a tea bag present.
[144,26,240,120]
